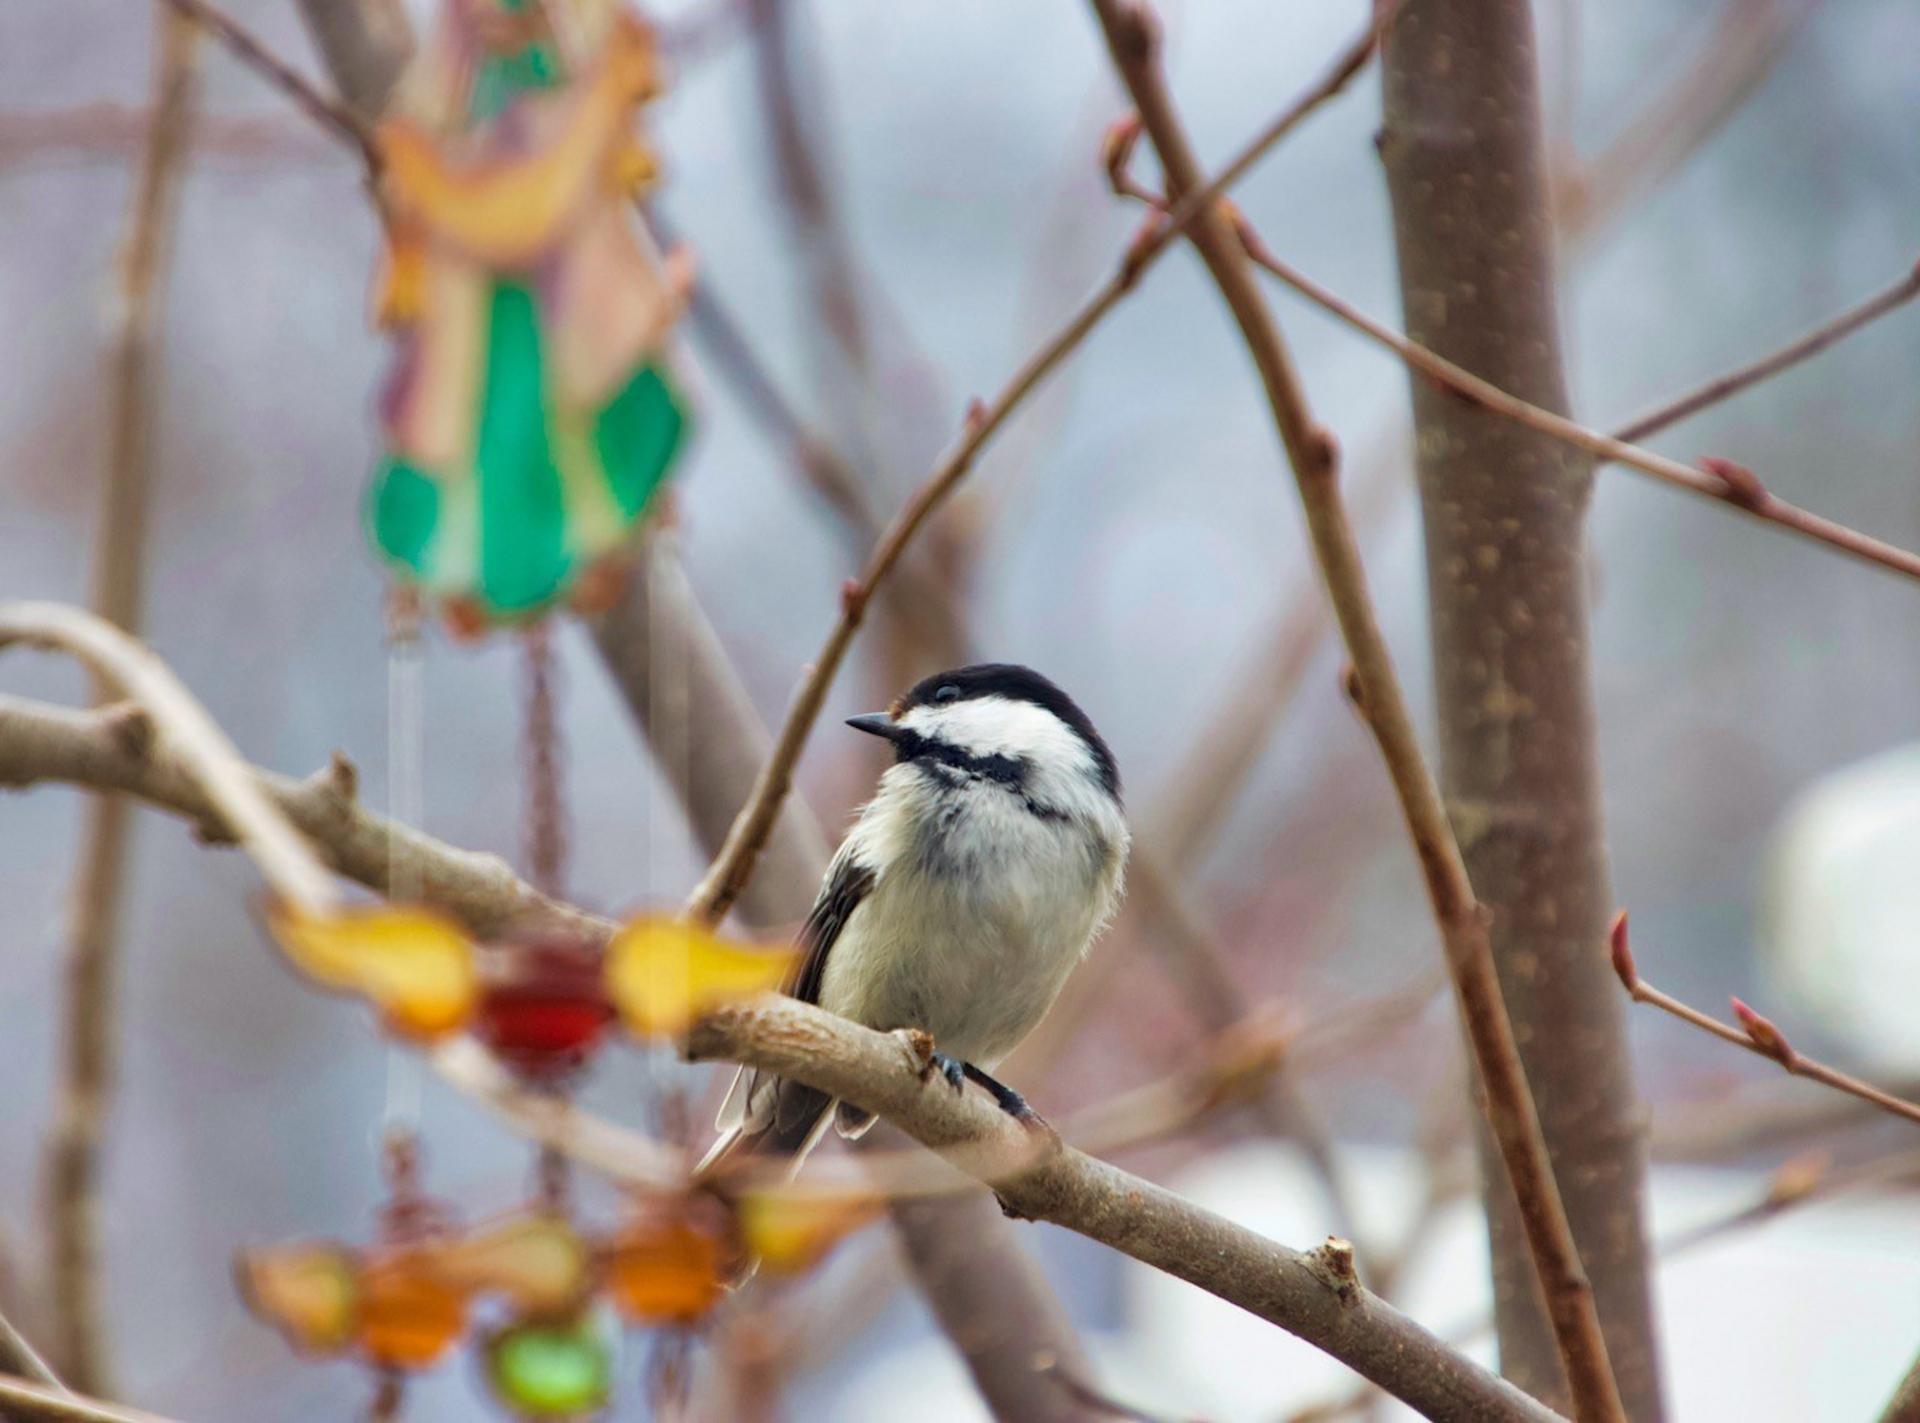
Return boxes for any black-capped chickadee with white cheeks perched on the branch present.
[701,663,1129,1170]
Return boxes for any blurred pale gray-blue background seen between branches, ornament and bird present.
[0,0,1920,1419]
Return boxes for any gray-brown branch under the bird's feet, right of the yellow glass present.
[687,997,1555,1419]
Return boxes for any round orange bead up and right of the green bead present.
[607,1193,739,1327]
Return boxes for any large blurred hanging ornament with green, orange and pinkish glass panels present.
[367,0,685,630]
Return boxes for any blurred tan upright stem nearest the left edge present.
[44,6,200,1394]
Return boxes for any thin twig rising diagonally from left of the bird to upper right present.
[687,5,1379,924]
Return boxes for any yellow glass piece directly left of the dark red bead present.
[269,904,480,1039]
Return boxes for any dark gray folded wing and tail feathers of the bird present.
[701,849,877,1170]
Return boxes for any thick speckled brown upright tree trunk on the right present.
[1380,0,1663,1423]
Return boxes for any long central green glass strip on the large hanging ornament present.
[476,282,572,613]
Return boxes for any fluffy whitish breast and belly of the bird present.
[820,764,1127,1070]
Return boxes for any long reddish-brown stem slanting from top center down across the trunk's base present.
[1092,0,1624,1423]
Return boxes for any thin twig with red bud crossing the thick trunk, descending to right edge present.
[1240,223,1920,578]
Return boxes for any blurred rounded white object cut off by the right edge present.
[1761,745,1920,1072]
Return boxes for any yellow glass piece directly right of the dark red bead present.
[607,914,795,1037]
